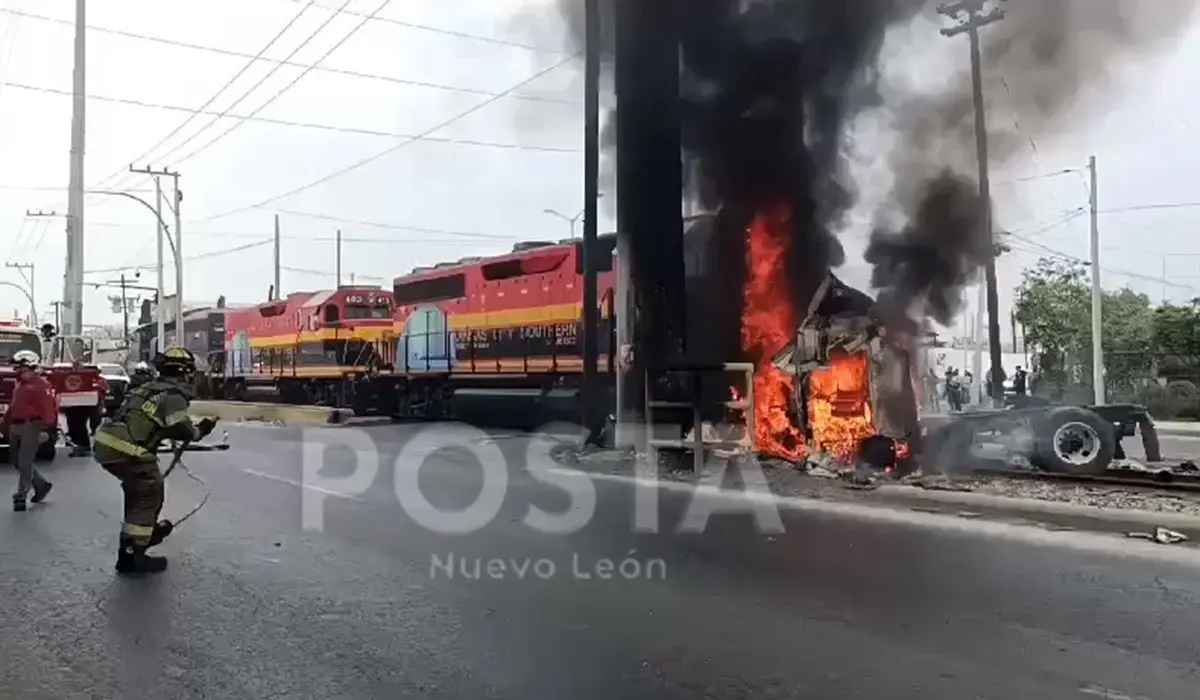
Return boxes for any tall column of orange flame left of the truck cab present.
[742,208,808,461]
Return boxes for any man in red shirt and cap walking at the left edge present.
[0,351,59,511]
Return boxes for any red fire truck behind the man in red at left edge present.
[0,321,101,461]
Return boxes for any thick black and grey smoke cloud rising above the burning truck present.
[522,0,1200,323]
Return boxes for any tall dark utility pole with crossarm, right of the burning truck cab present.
[937,0,1004,406]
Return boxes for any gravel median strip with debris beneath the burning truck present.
[556,448,1200,517]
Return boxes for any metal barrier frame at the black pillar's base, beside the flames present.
[644,363,756,473]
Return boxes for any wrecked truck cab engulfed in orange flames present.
[686,207,919,467]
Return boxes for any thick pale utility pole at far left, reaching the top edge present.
[62,0,88,335]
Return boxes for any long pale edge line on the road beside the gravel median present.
[550,467,1200,568]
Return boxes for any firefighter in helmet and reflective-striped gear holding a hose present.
[95,347,216,574]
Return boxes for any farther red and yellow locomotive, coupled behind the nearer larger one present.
[221,286,394,405]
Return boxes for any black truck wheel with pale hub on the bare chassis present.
[1030,406,1117,474]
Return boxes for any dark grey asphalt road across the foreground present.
[0,426,1200,700]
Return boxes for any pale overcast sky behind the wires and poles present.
[0,0,1200,336]
